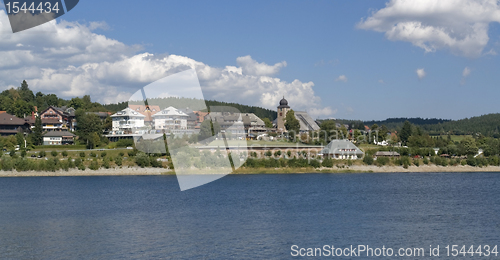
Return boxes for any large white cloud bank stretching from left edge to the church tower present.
[0,11,335,116]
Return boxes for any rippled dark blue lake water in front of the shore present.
[0,173,500,259]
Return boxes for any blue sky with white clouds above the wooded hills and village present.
[0,0,500,120]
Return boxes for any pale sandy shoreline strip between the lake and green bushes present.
[0,165,500,177]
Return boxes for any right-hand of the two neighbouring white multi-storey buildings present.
[152,106,189,130]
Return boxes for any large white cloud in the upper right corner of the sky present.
[357,0,500,57]
